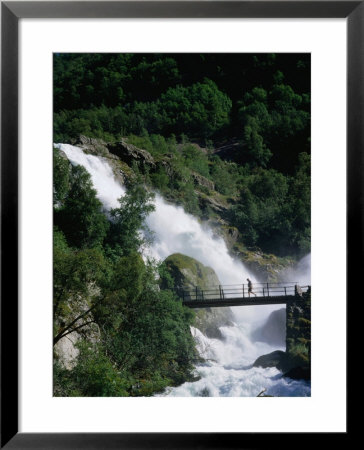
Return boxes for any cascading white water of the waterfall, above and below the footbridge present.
[56,144,310,396]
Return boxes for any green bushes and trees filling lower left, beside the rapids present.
[55,254,197,396]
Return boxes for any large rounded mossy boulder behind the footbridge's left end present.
[161,253,233,339]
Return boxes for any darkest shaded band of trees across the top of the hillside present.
[54,54,310,172]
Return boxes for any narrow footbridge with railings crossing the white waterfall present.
[176,282,310,308]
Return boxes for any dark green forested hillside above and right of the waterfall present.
[54,54,310,255]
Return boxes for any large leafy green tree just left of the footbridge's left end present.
[101,254,196,395]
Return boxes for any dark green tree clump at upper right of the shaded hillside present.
[239,80,310,171]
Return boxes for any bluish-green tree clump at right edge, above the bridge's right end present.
[231,160,310,255]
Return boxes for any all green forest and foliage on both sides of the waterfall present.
[54,53,310,396]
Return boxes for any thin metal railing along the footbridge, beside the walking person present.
[175,282,308,301]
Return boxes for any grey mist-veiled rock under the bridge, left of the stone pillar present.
[252,308,286,347]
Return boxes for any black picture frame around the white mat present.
[1,0,356,449]
